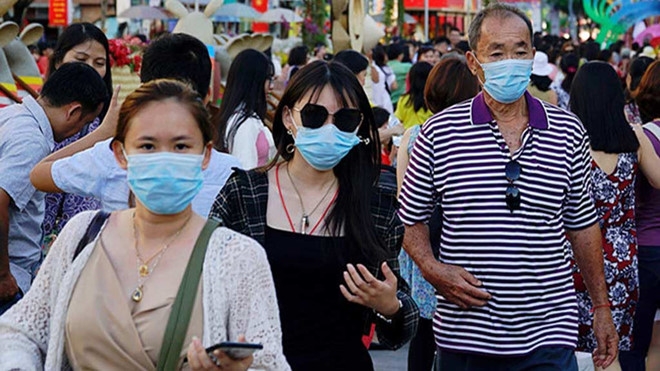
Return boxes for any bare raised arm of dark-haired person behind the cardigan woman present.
[30,86,121,193]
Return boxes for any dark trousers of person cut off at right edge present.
[619,246,660,371]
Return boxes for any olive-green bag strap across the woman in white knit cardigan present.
[156,219,218,371]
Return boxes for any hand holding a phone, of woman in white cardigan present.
[187,336,254,371]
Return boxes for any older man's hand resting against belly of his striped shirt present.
[422,261,491,309]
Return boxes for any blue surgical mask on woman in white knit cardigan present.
[124,152,204,215]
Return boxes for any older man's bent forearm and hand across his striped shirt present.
[403,223,491,309]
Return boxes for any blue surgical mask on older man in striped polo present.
[479,59,534,104]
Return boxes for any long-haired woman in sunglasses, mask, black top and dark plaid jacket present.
[211,61,418,370]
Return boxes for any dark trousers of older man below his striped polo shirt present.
[435,347,578,371]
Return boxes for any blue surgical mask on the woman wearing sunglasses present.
[294,124,360,171]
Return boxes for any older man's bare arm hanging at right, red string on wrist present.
[566,223,619,368]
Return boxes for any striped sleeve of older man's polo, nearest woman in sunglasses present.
[399,125,435,225]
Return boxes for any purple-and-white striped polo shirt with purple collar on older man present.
[399,93,597,356]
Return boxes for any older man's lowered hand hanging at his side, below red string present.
[592,307,619,369]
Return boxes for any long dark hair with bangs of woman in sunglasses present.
[268,61,386,264]
